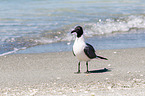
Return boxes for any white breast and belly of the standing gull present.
[73,36,90,61]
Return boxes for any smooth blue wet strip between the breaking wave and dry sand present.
[14,30,145,54]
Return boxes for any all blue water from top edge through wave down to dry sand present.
[0,0,145,56]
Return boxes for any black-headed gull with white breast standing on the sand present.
[71,26,108,73]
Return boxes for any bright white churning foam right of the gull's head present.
[85,16,145,37]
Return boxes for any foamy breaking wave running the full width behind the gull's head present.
[0,15,145,56]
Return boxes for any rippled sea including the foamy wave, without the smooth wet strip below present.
[0,0,145,53]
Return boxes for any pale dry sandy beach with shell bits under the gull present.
[0,48,145,96]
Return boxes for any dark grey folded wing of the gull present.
[84,43,97,59]
